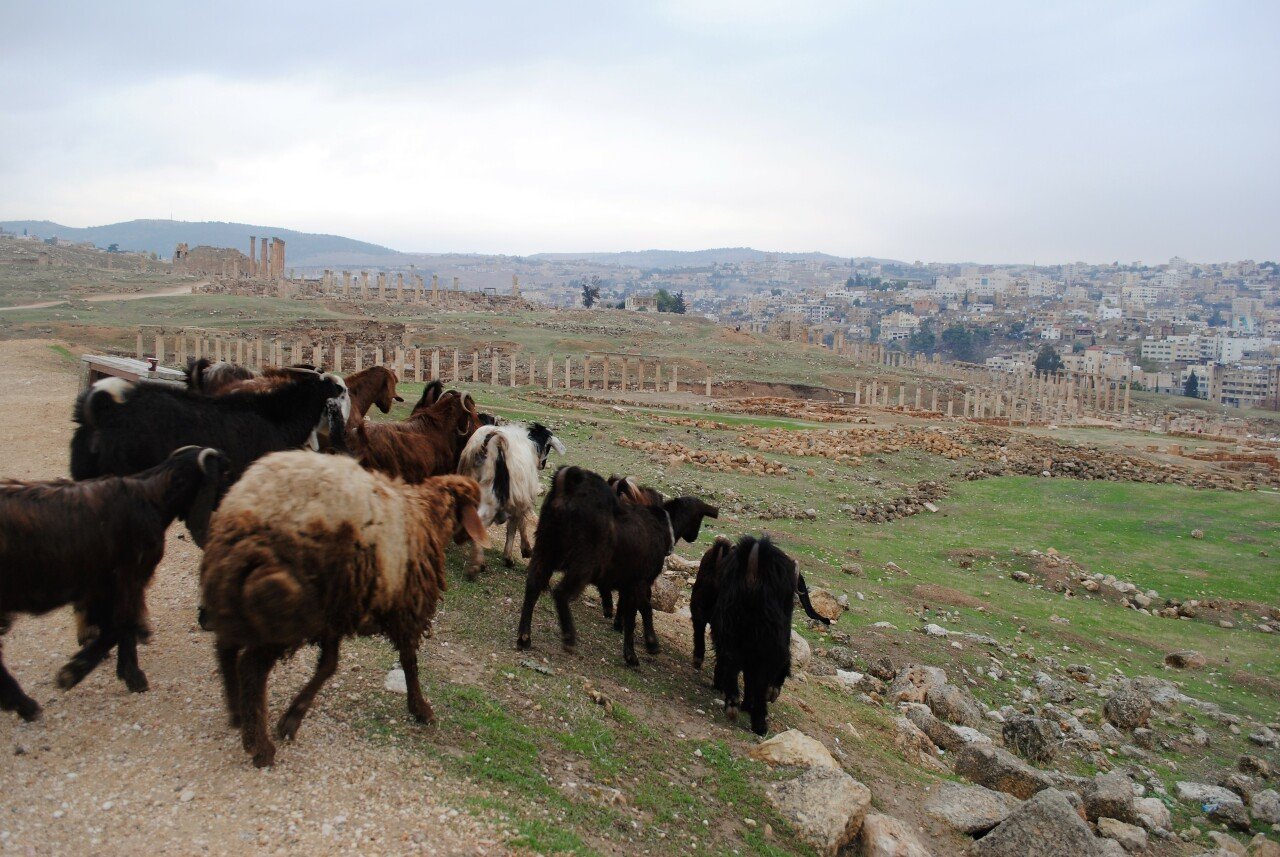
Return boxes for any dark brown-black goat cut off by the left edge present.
[0,446,229,720]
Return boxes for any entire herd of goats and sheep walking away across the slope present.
[0,361,827,766]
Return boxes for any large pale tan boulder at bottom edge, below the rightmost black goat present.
[768,767,872,857]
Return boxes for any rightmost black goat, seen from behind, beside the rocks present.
[694,536,800,735]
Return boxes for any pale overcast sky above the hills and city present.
[0,0,1280,263]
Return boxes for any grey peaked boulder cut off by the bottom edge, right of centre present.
[970,789,1100,857]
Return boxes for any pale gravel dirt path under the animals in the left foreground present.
[0,342,507,854]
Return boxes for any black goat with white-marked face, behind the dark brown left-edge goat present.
[72,370,346,524]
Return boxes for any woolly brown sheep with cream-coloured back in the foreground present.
[200,452,488,767]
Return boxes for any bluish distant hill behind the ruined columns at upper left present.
[0,220,401,267]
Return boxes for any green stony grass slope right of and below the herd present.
[317,384,1280,854]
